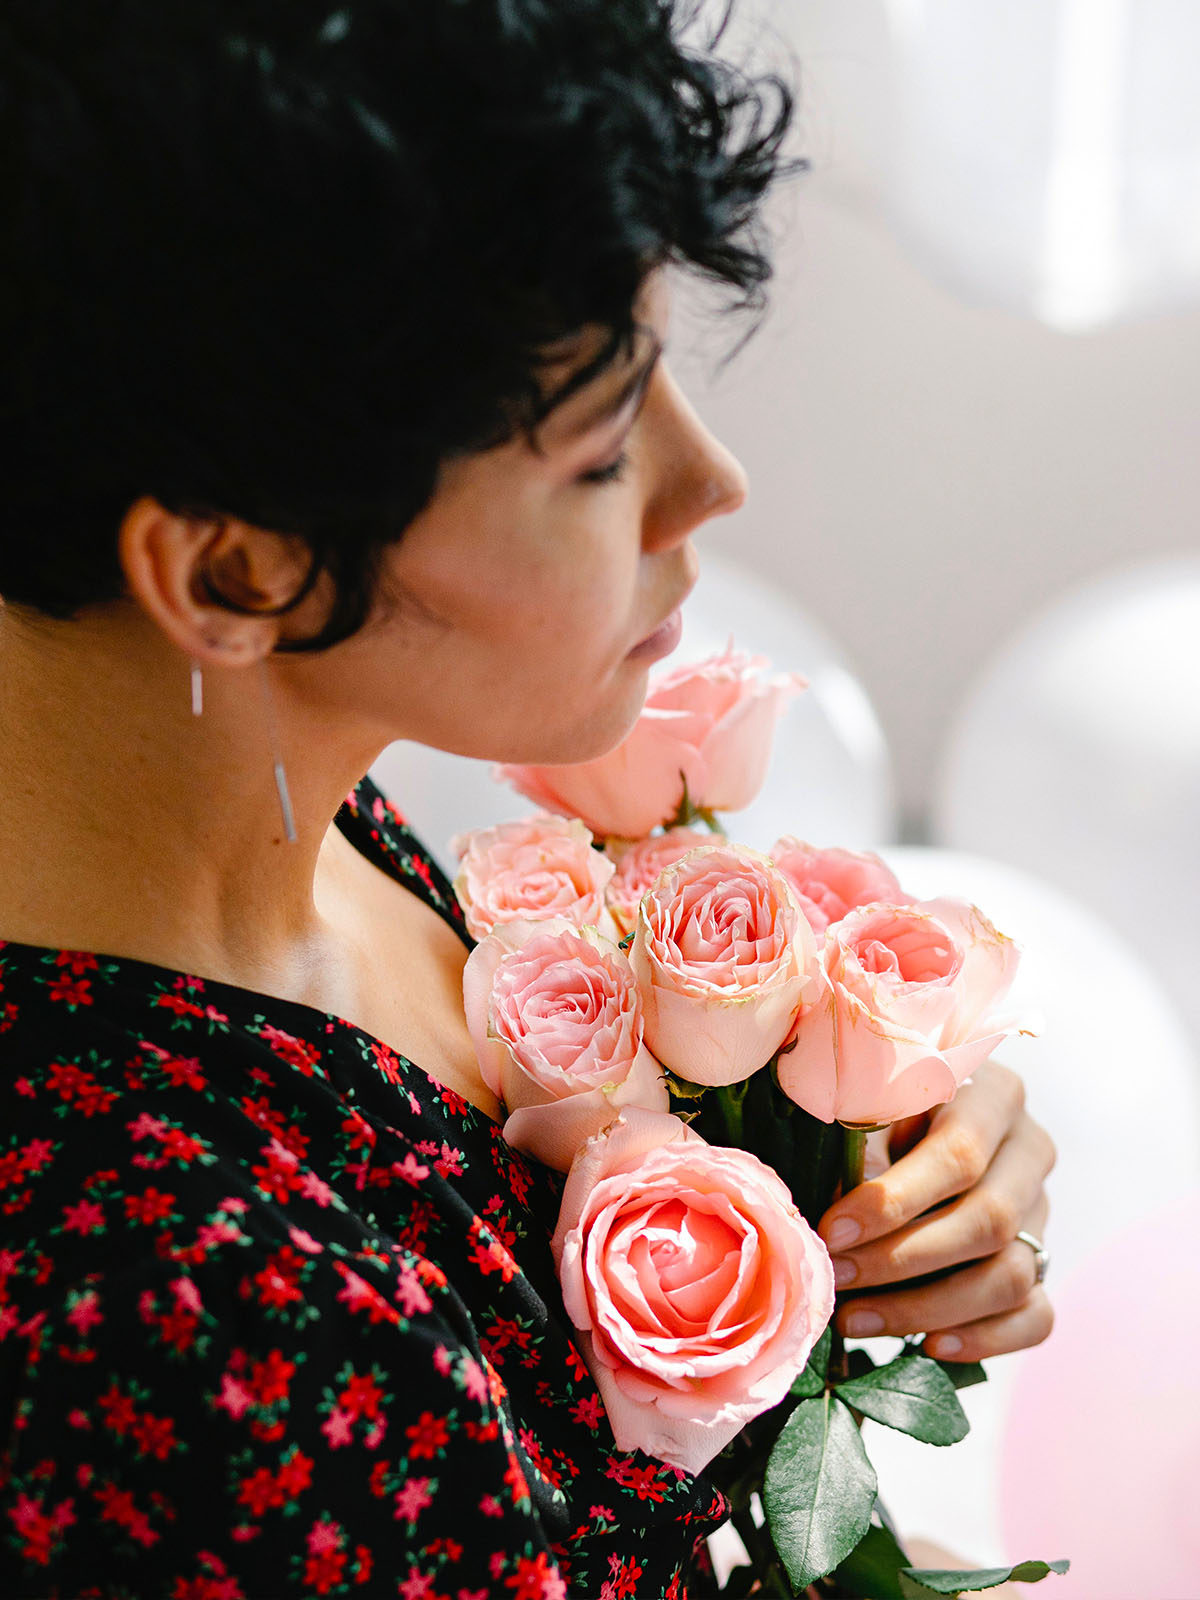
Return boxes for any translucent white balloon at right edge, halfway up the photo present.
[933,557,1200,1027]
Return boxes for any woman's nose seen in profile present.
[643,362,747,546]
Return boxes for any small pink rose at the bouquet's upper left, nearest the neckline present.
[451,816,616,939]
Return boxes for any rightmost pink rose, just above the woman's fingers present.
[779,899,1018,1126]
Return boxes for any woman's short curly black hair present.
[0,0,792,648]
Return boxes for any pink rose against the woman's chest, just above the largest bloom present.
[462,917,669,1173]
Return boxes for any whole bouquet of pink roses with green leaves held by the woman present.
[454,648,1066,1600]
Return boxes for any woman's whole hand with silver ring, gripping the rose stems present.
[819,1061,1054,1362]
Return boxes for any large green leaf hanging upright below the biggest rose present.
[763,1395,875,1589]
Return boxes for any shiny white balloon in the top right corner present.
[888,0,1200,330]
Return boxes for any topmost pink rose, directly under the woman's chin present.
[496,646,805,838]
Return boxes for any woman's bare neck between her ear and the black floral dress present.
[0,606,379,992]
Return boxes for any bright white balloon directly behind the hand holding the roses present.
[866,846,1200,1568]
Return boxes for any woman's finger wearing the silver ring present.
[837,1202,1048,1339]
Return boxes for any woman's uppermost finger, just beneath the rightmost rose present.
[819,1061,1024,1251]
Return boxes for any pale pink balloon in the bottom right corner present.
[1000,1196,1200,1600]
